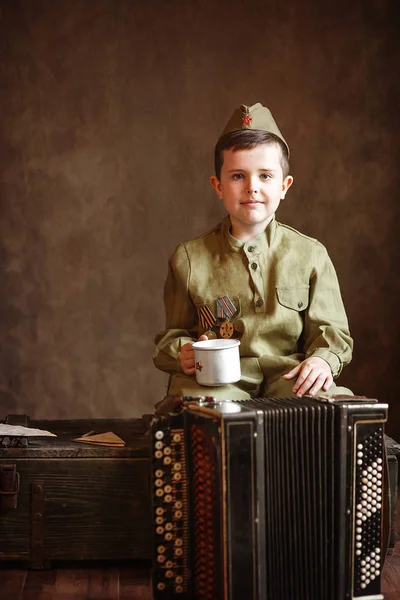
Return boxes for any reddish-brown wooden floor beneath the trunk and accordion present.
[0,541,400,600]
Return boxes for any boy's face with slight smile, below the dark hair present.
[210,144,293,241]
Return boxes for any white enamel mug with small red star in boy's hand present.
[193,339,241,386]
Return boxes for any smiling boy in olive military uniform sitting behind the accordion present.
[153,103,353,399]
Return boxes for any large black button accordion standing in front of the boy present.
[151,396,388,600]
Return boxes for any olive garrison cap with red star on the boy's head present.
[221,102,289,156]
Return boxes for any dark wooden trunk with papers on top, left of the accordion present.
[0,419,151,568]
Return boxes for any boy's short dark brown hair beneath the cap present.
[214,129,289,179]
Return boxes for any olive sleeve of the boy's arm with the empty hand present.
[304,243,353,377]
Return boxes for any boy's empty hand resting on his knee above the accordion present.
[283,356,333,398]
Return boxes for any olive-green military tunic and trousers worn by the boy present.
[153,216,353,398]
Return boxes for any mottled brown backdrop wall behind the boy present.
[0,0,400,438]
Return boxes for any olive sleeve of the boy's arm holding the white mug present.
[153,244,197,374]
